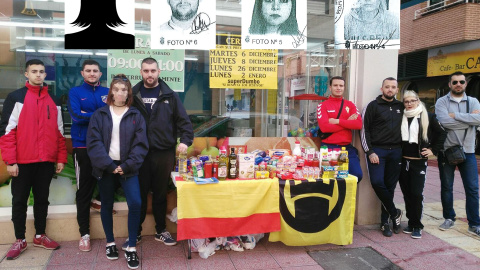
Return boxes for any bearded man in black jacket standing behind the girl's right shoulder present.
[122,57,193,250]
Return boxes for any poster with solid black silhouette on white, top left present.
[65,0,135,49]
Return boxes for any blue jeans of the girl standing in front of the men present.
[98,173,142,247]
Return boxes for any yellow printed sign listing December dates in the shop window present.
[210,34,278,89]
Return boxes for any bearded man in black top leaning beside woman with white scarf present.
[361,77,404,237]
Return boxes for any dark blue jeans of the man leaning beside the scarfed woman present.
[367,147,402,224]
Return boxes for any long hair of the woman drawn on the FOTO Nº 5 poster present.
[249,0,299,35]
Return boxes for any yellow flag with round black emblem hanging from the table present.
[269,175,357,246]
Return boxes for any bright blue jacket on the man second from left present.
[68,82,108,147]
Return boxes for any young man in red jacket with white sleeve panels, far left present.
[0,59,67,260]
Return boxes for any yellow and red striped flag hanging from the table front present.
[176,177,280,240]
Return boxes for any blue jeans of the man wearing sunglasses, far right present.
[438,153,480,226]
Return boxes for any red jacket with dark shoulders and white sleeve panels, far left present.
[0,82,67,164]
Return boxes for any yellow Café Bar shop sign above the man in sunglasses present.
[427,40,480,77]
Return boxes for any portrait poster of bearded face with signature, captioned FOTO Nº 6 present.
[150,0,217,50]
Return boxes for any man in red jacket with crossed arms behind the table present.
[317,76,363,182]
